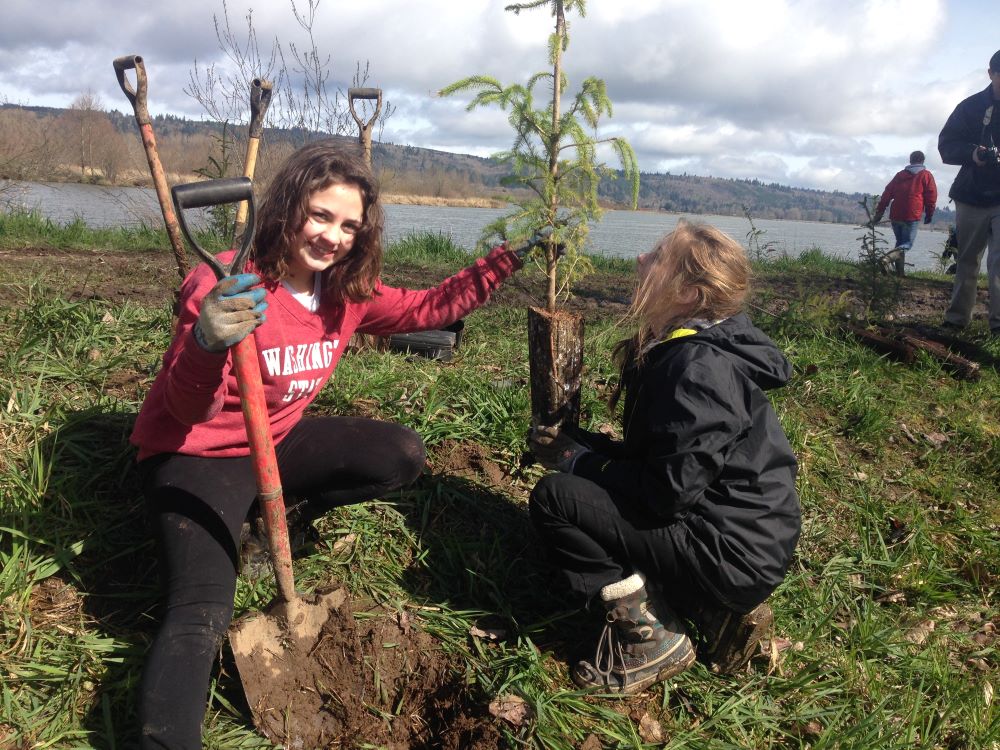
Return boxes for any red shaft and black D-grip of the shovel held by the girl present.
[171,177,298,620]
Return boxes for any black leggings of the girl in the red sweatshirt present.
[139,417,425,750]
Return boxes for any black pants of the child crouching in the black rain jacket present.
[529,473,710,612]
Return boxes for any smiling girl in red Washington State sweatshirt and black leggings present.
[131,140,532,748]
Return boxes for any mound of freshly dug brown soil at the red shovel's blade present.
[230,590,503,750]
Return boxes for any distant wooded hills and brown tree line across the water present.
[0,101,954,224]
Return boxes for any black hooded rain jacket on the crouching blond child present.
[573,314,801,611]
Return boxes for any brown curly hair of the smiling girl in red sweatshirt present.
[254,139,385,304]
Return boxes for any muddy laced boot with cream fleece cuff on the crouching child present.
[573,573,695,694]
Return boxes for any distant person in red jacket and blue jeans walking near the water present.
[873,151,937,276]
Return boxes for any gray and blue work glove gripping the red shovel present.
[194,273,267,352]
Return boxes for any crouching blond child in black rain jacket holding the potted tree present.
[529,221,801,693]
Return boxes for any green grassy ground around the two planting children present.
[0,217,1000,750]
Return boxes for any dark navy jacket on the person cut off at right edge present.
[938,84,1000,208]
